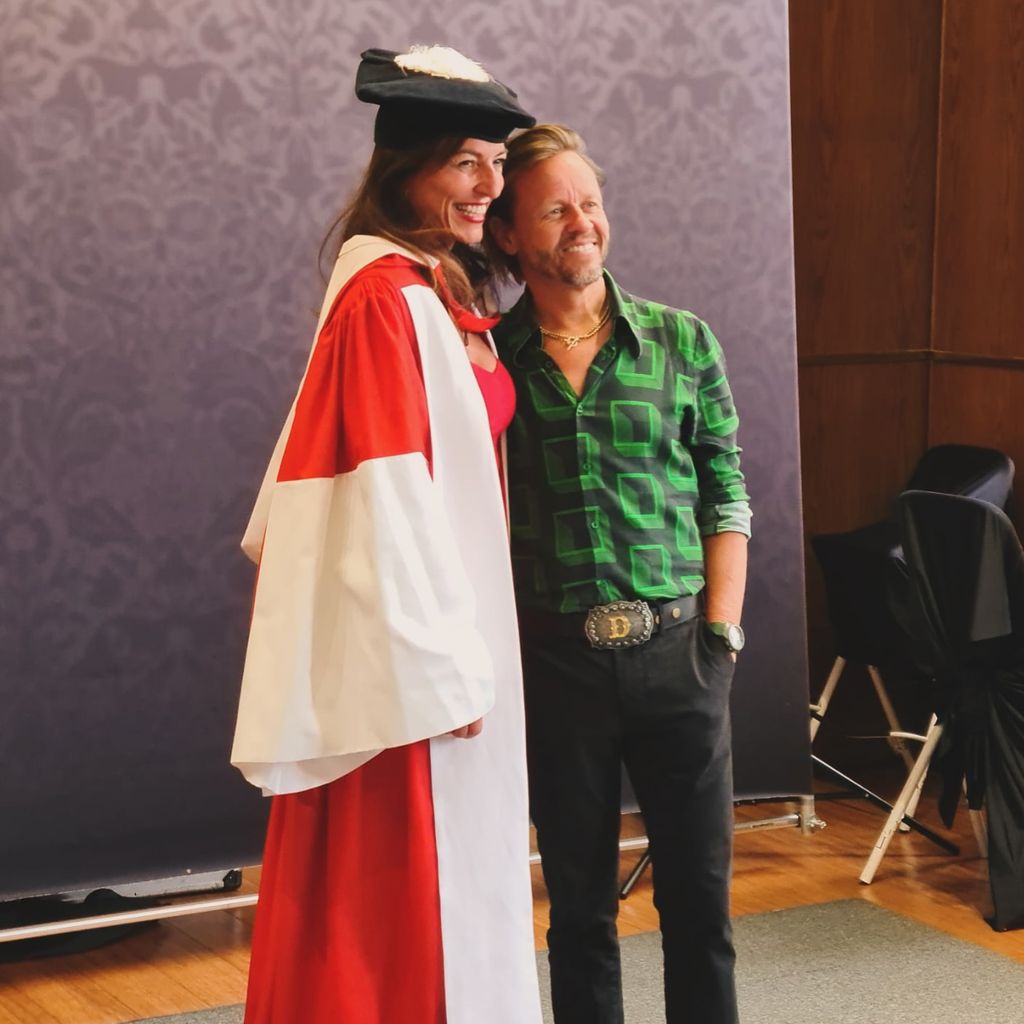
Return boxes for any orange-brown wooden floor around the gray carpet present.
[0,778,1024,1024]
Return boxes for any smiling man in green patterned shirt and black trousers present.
[488,125,750,1024]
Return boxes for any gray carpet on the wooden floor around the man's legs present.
[132,900,1024,1024]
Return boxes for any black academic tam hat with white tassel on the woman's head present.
[355,46,537,150]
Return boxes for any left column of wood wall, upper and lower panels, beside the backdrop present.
[790,0,942,760]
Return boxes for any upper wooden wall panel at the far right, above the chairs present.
[933,0,1024,354]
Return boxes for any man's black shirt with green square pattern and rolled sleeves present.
[495,272,751,612]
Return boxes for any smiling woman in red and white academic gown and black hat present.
[231,48,540,1024]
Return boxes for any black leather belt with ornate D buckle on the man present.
[519,594,700,650]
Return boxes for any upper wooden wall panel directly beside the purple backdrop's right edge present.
[790,0,942,355]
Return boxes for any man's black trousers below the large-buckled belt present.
[522,618,738,1024]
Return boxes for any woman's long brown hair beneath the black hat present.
[318,137,492,306]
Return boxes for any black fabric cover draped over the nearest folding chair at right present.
[899,490,1024,931]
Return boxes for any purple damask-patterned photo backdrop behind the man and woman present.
[0,0,809,897]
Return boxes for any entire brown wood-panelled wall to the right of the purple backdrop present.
[791,0,1024,764]
